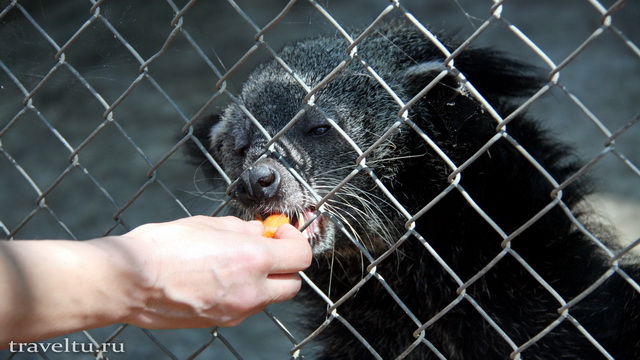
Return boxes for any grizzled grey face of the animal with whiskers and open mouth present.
[210,60,404,253]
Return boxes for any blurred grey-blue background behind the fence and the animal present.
[0,0,640,359]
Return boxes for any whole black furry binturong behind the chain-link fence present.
[193,21,640,359]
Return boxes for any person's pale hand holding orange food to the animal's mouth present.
[95,216,311,329]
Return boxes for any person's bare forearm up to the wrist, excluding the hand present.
[0,239,142,348]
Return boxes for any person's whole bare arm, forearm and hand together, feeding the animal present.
[0,216,311,349]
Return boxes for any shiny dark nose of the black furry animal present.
[236,164,280,203]
